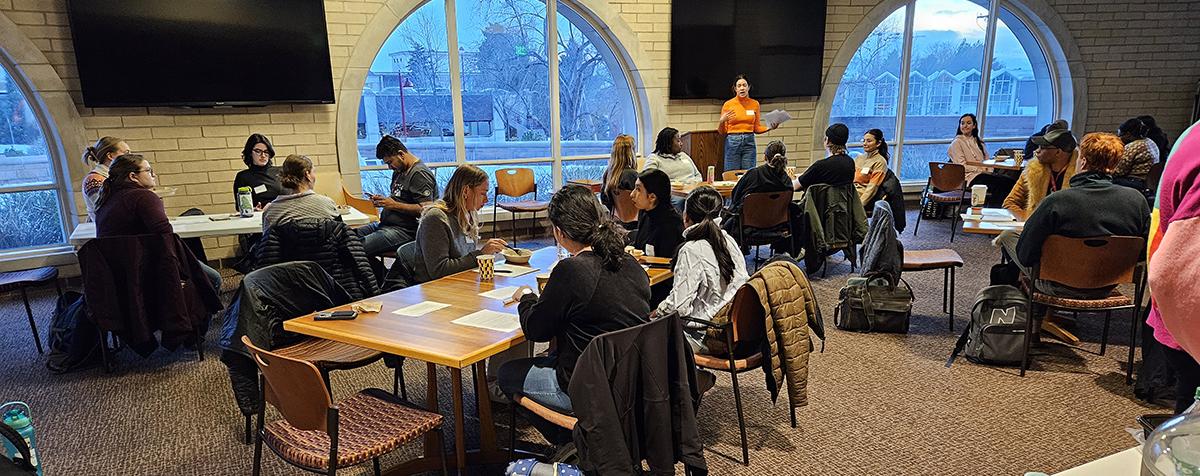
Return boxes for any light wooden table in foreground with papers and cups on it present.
[283,247,673,474]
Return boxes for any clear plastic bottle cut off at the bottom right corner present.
[1141,388,1200,476]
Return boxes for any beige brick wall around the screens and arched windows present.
[0,0,1200,258]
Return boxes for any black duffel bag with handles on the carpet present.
[834,277,913,333]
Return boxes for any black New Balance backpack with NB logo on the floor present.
[946,285,1030,367]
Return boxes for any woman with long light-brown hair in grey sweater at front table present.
[397,165,508,283]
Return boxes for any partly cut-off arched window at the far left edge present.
[0,64,66,253]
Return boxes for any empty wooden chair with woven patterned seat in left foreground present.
[241,336,446,476]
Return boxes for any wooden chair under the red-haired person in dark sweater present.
[1021,235,1146,384]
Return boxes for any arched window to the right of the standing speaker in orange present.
[822,0,1069,181]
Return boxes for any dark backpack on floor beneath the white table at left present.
[46,291,102,374]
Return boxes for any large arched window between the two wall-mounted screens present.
[358,0,641,202]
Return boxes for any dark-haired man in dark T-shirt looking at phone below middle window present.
[358,135,438,257]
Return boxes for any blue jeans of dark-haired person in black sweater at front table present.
[498,357,572,445]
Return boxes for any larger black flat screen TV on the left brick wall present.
[68,0,334,108]
